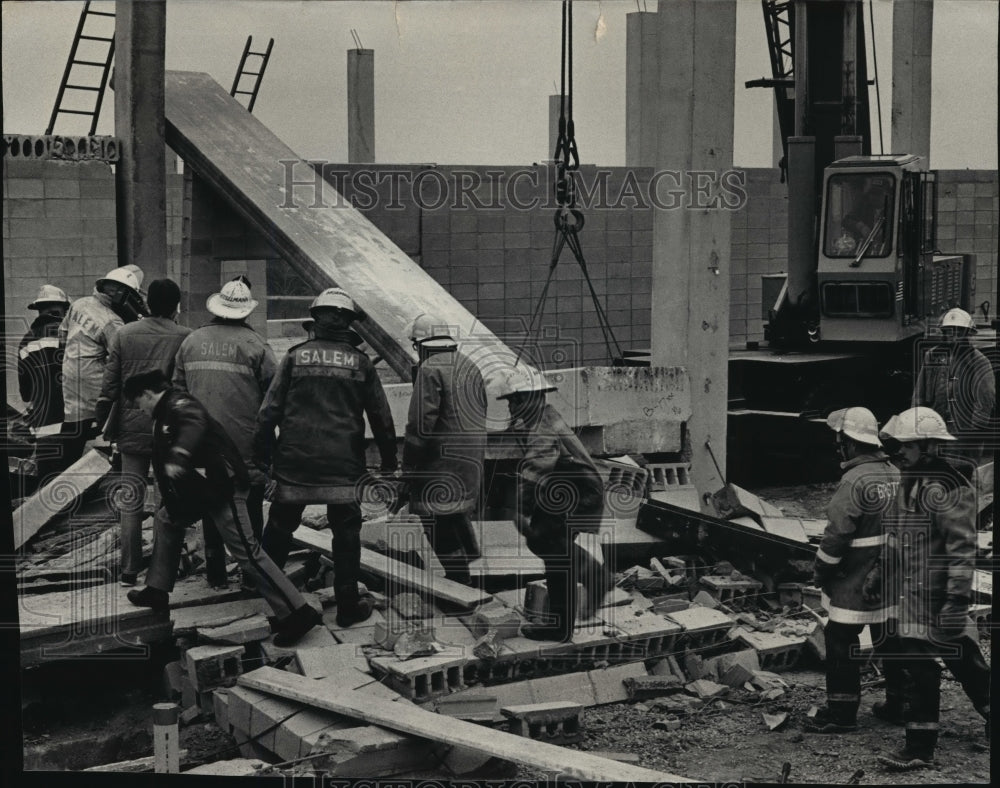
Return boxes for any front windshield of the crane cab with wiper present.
[823,172,896,257]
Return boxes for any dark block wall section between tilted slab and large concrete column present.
[317,165,653,366]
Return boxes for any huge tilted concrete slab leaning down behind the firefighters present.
[165,71,515,392]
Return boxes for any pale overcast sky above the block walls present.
[2,0,998,169]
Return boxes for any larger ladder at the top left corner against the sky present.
[45,0,115,136]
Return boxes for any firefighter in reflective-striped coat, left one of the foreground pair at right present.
[806,407,899,733]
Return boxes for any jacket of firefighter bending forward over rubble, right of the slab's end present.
[511,404,604,533]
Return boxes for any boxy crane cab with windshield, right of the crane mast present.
[814,155,975,343]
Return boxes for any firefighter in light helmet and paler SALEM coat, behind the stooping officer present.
[173,277,276,587]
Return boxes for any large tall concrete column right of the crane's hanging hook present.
[652,0,736,504]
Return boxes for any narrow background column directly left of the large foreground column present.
[625,11,660,167]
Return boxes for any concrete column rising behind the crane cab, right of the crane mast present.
[891,0,934,161]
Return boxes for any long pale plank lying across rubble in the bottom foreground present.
[239,668,688,782]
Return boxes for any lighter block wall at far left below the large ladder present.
[3,157,118,407]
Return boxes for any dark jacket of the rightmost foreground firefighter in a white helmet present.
[883,458,977,643]
